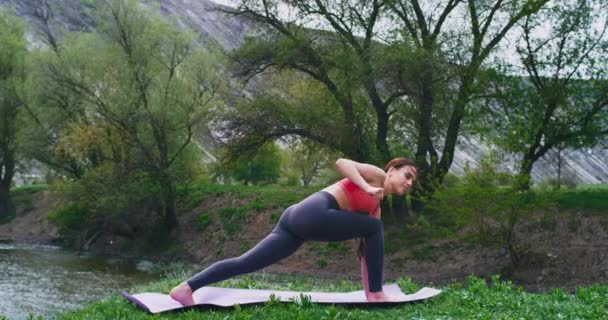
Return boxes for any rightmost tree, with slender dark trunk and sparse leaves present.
[487,0,608,189]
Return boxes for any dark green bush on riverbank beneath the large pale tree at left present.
[49,164,160,248]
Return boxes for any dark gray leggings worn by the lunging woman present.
[187,191,384,292]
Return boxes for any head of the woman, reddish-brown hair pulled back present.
[384,158,418,194]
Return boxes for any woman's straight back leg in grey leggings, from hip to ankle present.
[186,224,303,291]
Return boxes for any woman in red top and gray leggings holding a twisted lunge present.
[169,158,417,306]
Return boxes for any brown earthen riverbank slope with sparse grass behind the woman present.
[0,187,608,291]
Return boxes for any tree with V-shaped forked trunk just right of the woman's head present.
[390,0,548,198]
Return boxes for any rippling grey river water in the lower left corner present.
[0,243,160,320]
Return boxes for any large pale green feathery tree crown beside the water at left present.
[24,0,222,234]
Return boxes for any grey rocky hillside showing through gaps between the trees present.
[0,0,608,183]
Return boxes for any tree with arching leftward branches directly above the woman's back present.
[225,0,405,163]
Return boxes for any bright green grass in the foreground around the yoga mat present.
[50,276,608,320]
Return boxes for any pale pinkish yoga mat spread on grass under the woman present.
[122,283,441,313]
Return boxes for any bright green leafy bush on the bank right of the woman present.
[427,157,553,267]
